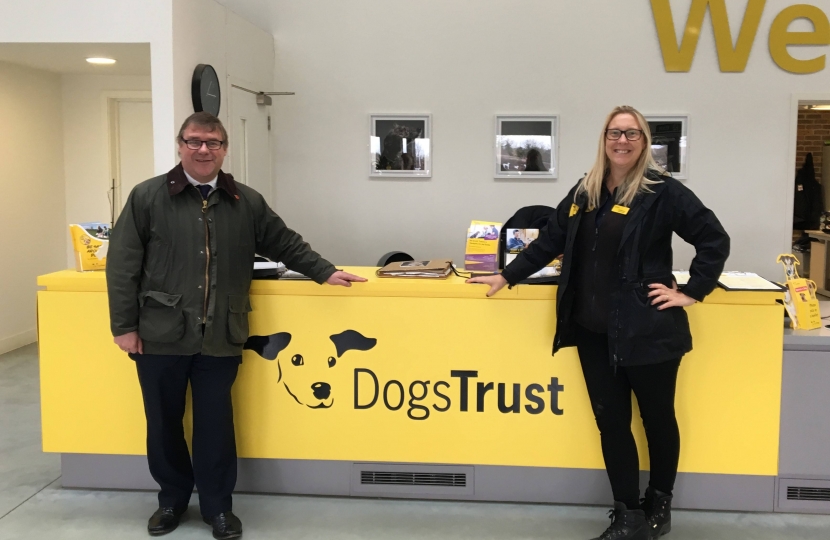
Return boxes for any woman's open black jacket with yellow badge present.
[502,172,729,366]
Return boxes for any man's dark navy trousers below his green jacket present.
[130,354,242,516]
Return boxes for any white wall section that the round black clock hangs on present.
[170,0,274,141]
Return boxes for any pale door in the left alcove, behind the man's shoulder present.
[110,99,155,219]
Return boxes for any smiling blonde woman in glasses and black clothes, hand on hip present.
[468,106,729,540]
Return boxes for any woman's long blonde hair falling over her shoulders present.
[576,105,665,209]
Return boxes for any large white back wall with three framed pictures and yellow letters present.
[273,0,830,278]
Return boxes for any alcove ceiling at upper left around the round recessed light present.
[0,43,150,75]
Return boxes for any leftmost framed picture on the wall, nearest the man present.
[369,114,432,178]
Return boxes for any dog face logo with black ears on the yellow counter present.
[244,330,378,409]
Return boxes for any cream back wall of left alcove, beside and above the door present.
[61,75,154,267]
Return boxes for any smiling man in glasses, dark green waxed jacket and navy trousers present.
[107,112,366,540]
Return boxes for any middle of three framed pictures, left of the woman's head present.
[493,115,559,179]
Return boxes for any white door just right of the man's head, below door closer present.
[225,85,274,208]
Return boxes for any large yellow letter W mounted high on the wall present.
[651,0,766,72]
